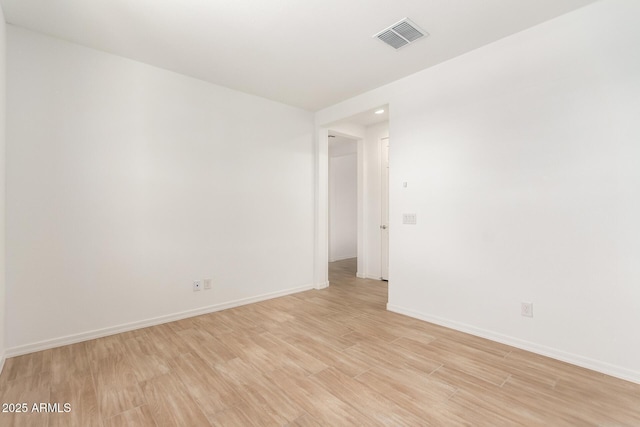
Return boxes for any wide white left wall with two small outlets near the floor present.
[6,26,314,354]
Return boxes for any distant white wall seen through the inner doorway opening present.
[329,138,358,262]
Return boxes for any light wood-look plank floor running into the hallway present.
[0,260,640,427]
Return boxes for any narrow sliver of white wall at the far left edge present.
[0,6,7,372]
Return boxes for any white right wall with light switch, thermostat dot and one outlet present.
[316,0,640,382]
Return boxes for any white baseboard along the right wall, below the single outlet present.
[387,304,640,384]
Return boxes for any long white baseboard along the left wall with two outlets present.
[0,282,316,362]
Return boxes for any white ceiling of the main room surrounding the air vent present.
[0,0,594,111]
